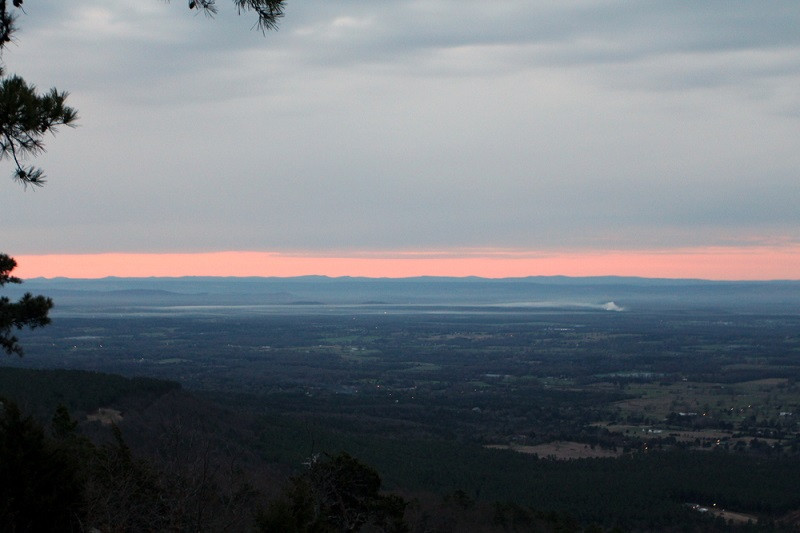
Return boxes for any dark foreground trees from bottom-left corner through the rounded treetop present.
[0,388,408,533]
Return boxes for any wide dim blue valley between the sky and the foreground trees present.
[0,278,800,531]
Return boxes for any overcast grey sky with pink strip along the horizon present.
[0,0,800,279]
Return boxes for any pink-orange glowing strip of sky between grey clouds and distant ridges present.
[14,245,800,280]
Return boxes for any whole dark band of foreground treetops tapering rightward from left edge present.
[0,390,580,533]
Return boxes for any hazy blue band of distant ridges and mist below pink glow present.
[4,276,800,313]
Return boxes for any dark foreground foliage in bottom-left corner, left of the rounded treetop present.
[0,399,262,532]
